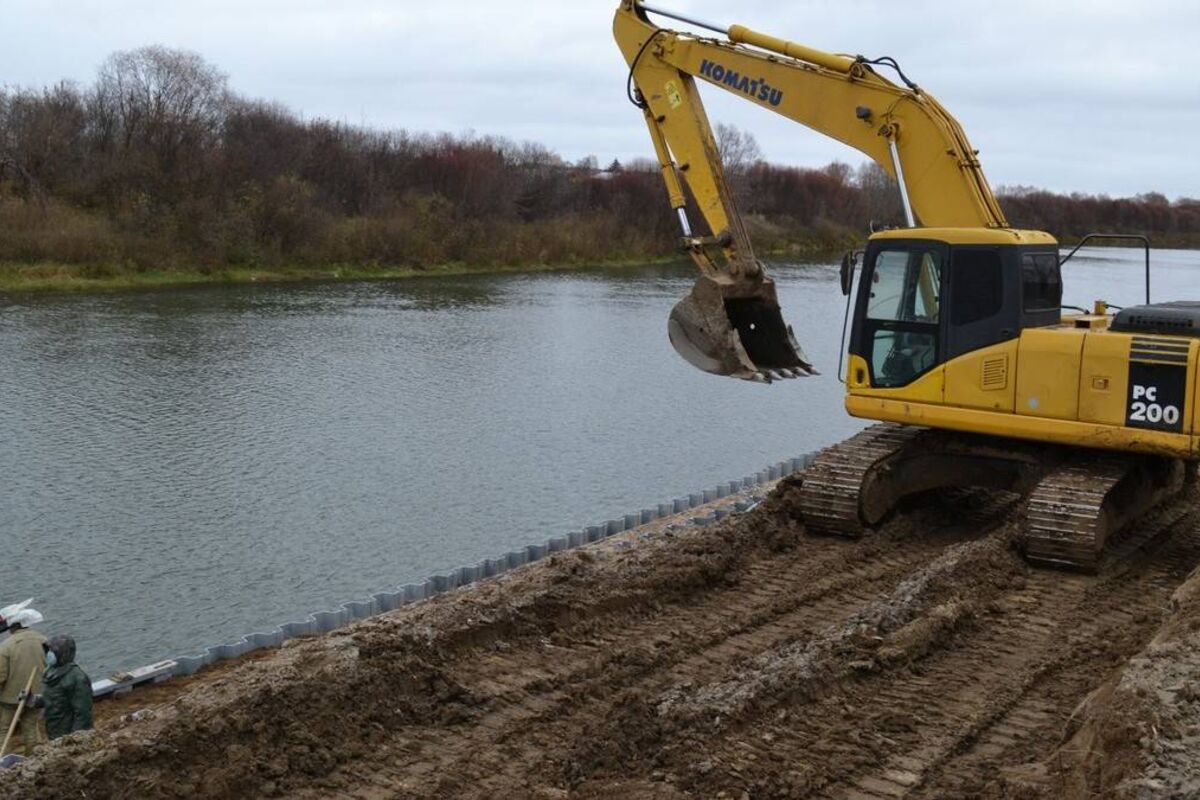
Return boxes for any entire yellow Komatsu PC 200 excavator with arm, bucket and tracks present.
[613,0,1200,571]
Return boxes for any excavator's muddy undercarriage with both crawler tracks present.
[800,423,1184,572]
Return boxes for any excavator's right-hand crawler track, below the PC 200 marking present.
[1022,453,1183,572]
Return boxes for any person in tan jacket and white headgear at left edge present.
[0,600,46,756]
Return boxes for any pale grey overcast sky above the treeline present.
[0,0,1200,199]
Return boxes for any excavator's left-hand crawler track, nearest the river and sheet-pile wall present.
[800,422,925,539]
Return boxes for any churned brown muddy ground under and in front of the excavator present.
[0,479,1200,800]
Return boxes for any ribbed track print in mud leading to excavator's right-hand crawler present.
[648,513,1200,800]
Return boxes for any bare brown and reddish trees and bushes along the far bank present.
[0,47,1200,284]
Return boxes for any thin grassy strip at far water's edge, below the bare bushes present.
[0,255,683,294]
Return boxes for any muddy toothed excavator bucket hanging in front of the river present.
[667,275,816,383]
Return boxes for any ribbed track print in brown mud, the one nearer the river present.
[292,497,1007,798]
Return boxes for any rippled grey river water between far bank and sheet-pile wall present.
[0,249,1200,678]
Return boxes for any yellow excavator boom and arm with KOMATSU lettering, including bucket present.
[613,0,1008,381]
